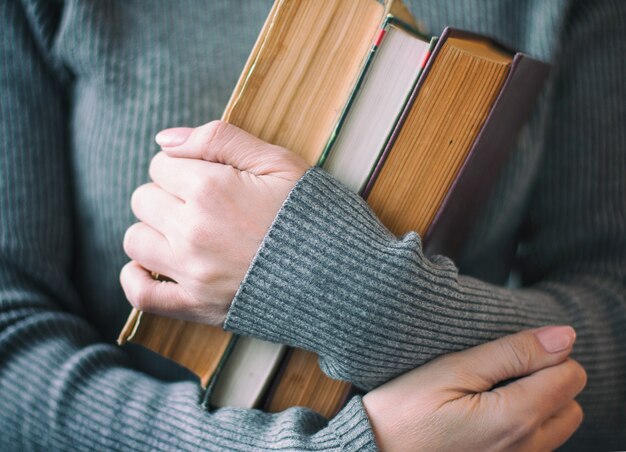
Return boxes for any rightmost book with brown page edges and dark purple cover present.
[266,28,548,412]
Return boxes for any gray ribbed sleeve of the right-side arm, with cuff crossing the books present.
[225,1,626,440]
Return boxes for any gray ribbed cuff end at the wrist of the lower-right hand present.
[328,396,378,451]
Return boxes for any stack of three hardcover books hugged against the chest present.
[118,0,549,417]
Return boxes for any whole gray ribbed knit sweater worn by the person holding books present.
[0,0,626,450]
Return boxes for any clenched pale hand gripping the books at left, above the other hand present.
[120,121,308,325]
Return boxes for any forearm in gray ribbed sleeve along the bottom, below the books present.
[0,291,374,450]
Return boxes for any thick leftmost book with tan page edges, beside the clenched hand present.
[118,0,413,411]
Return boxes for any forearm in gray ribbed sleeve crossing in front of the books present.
[225,166,626,434]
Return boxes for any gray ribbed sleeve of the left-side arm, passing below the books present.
[0,1,375,450]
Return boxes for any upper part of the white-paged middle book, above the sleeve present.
[318,17,434,193]
